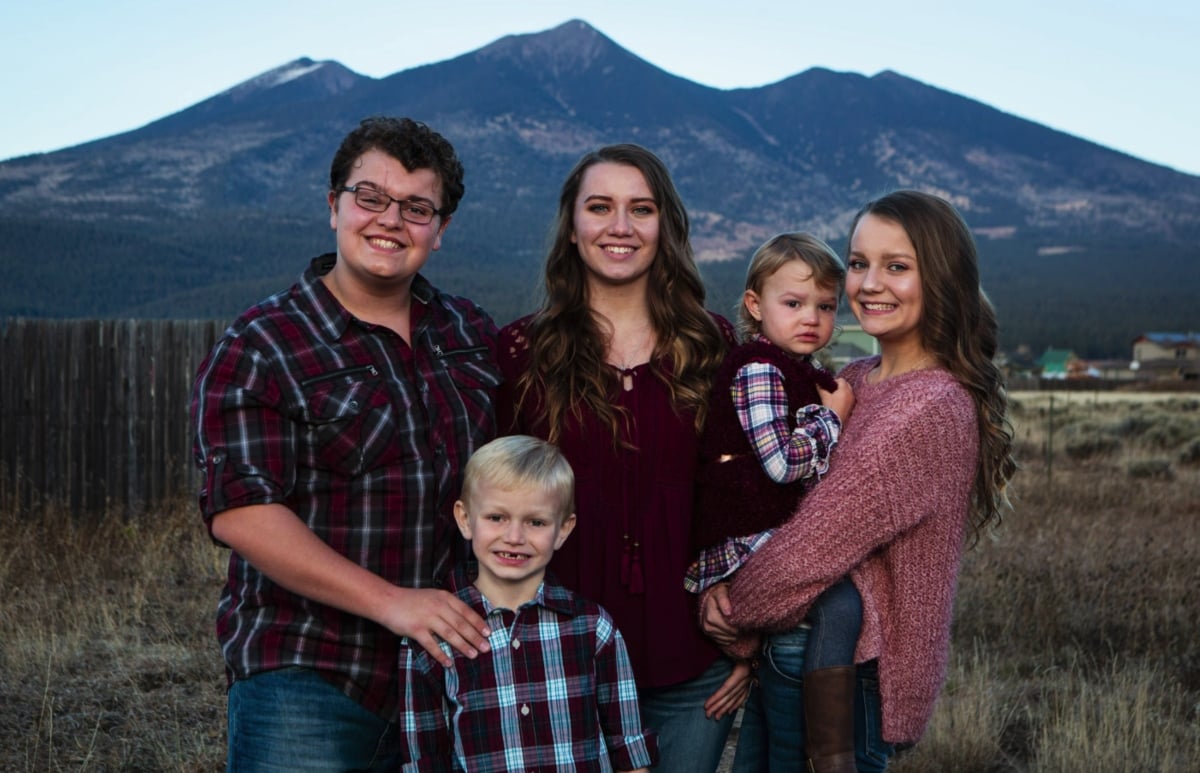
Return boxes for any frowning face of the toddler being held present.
[743,260,838,354]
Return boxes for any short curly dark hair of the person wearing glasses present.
[329,115,464,217]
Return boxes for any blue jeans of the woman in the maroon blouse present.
[637,658,733,773]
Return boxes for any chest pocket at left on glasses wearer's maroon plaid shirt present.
[302,365,400,475]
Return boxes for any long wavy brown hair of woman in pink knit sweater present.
[847,191,1016,537]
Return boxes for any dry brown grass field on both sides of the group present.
[0,393,1200,773]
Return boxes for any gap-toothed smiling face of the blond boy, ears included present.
[454,481,575,609]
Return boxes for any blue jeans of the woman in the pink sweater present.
[733,625,895,773]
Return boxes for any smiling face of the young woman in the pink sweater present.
[846,214,923,348]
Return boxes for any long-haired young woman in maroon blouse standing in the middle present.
[497,144,750,773]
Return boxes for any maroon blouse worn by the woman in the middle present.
[496,317,732,688]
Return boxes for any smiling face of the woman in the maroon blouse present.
[571,162,659,292]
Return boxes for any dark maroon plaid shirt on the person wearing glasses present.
[192,254,502,719]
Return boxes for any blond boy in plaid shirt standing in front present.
[400,436,658,772]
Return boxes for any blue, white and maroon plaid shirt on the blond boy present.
[400,564,658,773]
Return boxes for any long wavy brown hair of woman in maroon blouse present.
[517,144,726,443]
